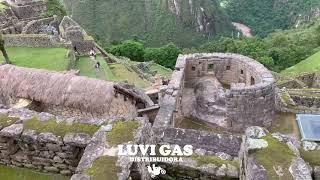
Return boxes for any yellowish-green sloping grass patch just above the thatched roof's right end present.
[109,64,150,88]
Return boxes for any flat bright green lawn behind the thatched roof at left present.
[0,47,68,71]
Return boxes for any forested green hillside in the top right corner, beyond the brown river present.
[221,0,320,37]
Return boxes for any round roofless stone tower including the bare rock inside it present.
[155,53,275,132]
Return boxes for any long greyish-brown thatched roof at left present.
[0,65,151,114]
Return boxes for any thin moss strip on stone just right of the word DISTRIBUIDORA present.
[191,155,239,170]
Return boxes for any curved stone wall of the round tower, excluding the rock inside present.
[155,53,275,131]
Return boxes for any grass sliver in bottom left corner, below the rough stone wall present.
[0,165,70,180]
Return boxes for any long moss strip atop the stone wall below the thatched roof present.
[23,117,99,137]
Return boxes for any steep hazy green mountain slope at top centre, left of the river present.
[63,0,231,47]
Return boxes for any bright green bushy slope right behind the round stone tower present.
[196,22,320,72]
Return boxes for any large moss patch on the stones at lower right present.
[255,135,295,180]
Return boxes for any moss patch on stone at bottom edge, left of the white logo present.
[85,156,120,180]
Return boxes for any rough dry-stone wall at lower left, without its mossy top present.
[0,109,91,175]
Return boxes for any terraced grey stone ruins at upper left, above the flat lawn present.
[0,0,98,55]
